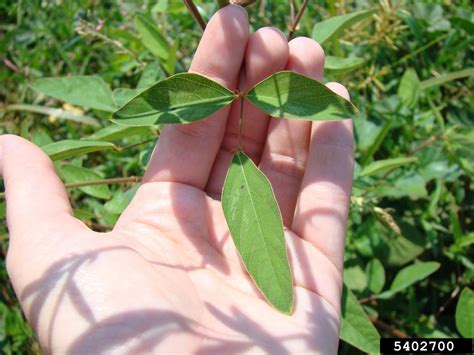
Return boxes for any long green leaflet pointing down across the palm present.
[222,152,293,314]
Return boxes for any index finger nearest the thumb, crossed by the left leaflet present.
[143,5,248,189]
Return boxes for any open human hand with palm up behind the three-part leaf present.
[0,6,353,354]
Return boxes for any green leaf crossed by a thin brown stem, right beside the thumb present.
[59,164,110,200]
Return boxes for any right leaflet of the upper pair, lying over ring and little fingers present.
[246,71,357,121]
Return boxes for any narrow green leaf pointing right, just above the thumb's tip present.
[41,140,115,160]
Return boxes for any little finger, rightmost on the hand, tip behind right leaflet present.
[293,83,354,270]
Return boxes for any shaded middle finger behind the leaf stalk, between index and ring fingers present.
[206,27,288,198]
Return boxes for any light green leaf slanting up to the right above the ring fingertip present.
[312,10,375,44]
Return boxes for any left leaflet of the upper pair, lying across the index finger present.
[113,73,237,126]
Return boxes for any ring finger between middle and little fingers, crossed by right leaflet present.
[260,37,324,226]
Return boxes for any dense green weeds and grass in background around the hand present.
[0,0,474,354]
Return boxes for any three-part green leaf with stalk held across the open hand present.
[112,71,356,314]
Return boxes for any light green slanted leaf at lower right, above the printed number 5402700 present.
[377,261,440,298]
